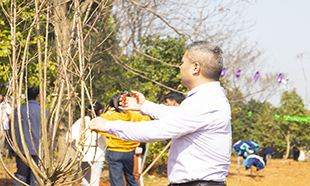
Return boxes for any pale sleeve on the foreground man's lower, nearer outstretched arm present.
[105,103,206,143]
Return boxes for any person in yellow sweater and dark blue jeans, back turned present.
[100,94,150,186]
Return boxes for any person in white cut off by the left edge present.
[0,94,12,153]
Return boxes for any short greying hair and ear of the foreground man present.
[186,41,223,81]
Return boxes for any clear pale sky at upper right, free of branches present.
[245,0,310,110]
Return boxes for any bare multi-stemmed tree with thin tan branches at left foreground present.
[1,0,112,185]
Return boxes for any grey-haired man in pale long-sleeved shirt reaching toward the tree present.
[89,41,232,186]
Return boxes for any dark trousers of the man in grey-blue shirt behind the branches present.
[13,155,38,186]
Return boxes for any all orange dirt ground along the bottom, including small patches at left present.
[0,157,310,186]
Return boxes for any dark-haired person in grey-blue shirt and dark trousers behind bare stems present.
[10,87,48,186]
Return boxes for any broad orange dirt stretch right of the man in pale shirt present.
[227,157,310,186]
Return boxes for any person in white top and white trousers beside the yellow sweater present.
[71,102,106,186]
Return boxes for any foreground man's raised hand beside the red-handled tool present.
[119,91,146,111]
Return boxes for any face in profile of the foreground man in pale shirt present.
[179,51,193,88]
